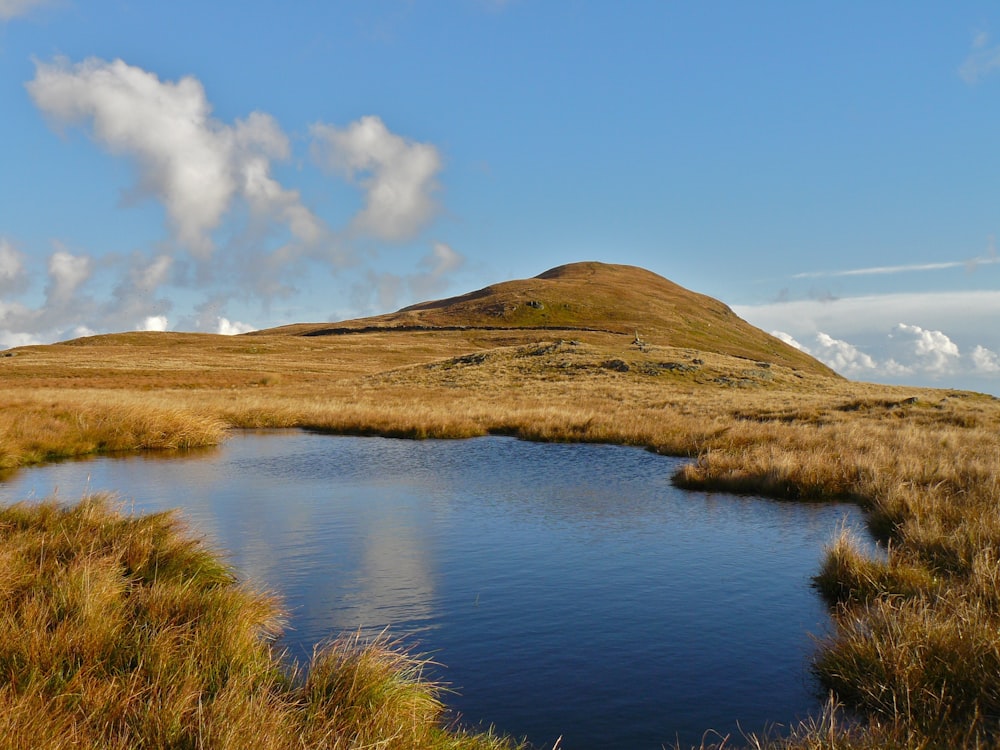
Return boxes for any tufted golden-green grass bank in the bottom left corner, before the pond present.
[0,497,513,750]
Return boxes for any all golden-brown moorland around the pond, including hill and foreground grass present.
[0,264,1000,748]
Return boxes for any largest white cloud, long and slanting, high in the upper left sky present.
[27,58,322,259]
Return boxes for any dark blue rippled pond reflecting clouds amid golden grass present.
[0,431,862,750]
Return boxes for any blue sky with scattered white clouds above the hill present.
[0,0,1000,395]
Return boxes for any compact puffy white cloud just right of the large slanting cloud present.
[311,116,442,241]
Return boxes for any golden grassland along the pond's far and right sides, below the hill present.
[0,331,1000,748]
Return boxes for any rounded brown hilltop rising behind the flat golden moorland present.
[262,262,836,377]
